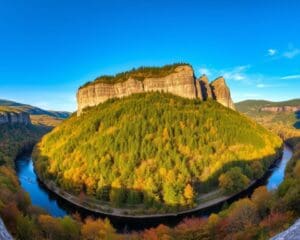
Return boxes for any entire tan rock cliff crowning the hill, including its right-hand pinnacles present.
[77,65,235,115]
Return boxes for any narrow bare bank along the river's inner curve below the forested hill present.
[36,145,291,219]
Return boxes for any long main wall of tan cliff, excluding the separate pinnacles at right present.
[77,65,196,115]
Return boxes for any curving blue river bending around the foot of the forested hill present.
[16,146,292,232]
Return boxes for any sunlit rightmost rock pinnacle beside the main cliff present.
[210,77,235,109]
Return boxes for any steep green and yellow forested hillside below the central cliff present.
[35,93,282,213]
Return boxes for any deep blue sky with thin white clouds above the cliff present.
[0,0,300,111]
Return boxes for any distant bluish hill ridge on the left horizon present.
[0,99,71,119]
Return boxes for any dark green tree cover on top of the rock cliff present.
[81,63,190,88]
